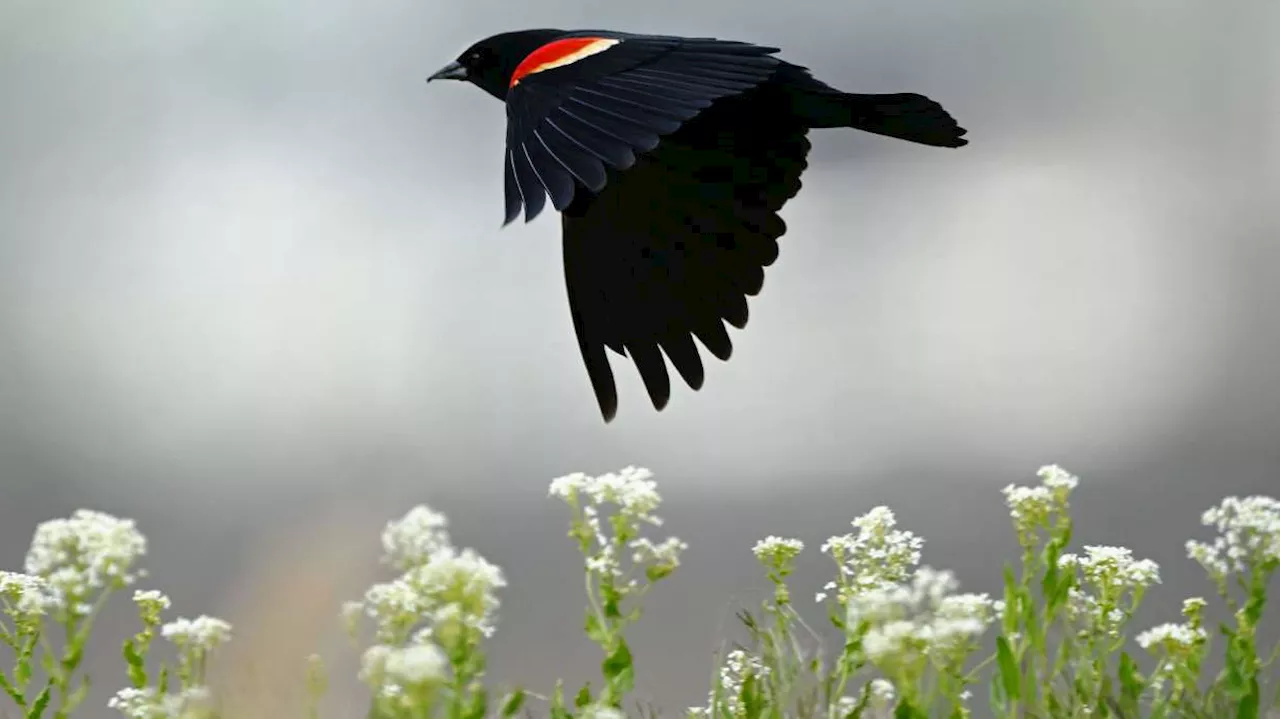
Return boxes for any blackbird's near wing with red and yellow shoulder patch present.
[503,31,780,223]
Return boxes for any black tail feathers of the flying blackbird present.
[840,92,969,147]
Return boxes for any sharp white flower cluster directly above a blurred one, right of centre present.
[817,507,924,604]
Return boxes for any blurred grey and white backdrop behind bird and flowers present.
[0,0,1280,716]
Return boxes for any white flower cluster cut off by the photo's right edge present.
[1187,496,1280,585]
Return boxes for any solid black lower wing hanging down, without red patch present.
[562,86,809,421]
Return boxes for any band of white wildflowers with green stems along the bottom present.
[0,467,1280,719]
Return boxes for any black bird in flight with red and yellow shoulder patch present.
[429,29,968,422]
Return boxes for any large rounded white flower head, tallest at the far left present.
[26,509,147,615]
